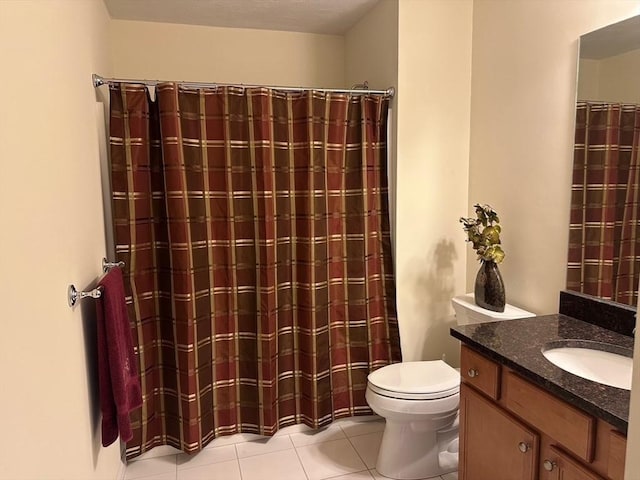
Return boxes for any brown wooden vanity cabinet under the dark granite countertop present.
[459,345,626,480]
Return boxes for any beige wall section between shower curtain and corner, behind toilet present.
[396,0,473,364]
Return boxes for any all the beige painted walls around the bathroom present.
[5,0,640,480]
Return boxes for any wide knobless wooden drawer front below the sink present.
[502,371,595,462]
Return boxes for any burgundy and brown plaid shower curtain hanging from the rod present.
[110,83,400,458]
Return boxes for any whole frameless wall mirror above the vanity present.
[567,15,640,307]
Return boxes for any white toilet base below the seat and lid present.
[376,419,458,480]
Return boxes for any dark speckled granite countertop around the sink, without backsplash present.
[451,314,633,434]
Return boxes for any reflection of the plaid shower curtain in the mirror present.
[567,102,640,306]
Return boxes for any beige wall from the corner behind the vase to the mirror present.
[467,0,640,480]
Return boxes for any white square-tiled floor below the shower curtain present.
[124,417,458,480]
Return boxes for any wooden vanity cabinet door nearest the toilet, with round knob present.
[459,384,539,480]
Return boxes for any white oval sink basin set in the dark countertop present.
[542,340,633,390]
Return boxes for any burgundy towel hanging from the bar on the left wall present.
[96,267,142,447]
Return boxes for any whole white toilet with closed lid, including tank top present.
[366,294,534,480]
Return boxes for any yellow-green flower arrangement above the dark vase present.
[460,203,504,263]
